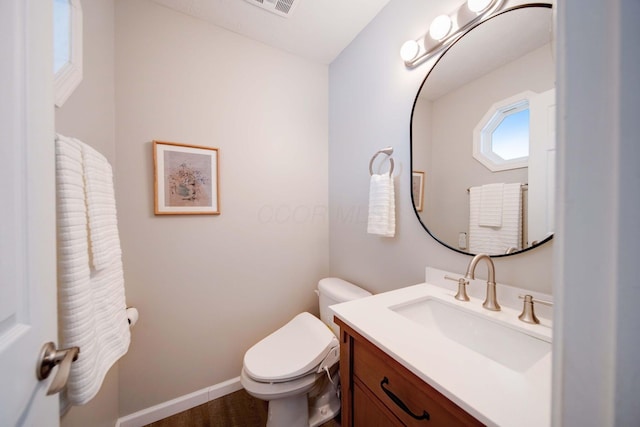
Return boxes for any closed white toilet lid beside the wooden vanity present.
[244,313,339,382]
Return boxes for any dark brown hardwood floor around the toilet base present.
[145,390,340,427]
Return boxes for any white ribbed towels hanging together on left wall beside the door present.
[56,135,131,407]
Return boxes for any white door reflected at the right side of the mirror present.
[528,89,556,244]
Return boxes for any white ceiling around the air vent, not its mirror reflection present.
[153,0,389,64]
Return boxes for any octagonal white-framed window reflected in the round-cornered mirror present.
[473,94,529,172]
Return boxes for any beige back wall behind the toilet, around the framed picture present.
[115,0,329,415]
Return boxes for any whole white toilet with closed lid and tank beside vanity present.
[240,277,371,427]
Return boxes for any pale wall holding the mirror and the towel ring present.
[329,0,553,293]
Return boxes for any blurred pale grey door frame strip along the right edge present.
[553,0,640,427]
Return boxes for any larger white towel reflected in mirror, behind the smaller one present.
[469,183,522,255]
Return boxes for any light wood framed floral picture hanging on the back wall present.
[153,141,220,215]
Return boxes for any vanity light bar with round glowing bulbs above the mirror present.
[400,0,504,68]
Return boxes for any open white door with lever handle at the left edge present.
[0,0,59,427]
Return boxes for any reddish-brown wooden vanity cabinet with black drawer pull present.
[335,317,483,427]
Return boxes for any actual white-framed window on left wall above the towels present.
[53,0,82,107]
